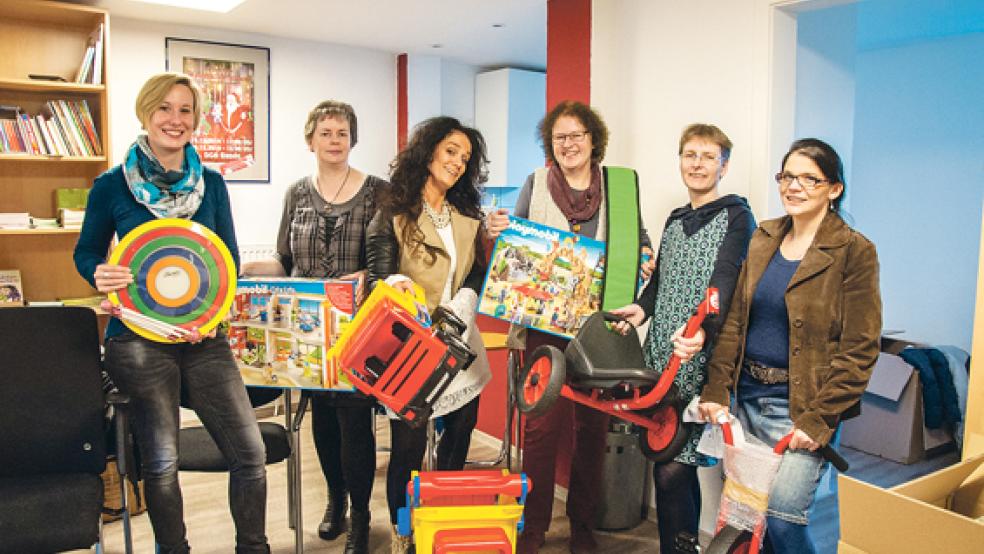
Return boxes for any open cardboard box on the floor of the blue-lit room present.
[841,352,953,464]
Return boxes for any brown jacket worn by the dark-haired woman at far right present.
[701,212,882,444]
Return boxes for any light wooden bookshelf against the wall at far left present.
[0,0,110,300]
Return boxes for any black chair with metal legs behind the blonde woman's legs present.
[178,387,309,553]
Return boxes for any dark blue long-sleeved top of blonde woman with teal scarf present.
[74,166,239,338]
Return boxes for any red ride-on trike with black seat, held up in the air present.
[516,288,719,462]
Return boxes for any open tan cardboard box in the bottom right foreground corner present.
[837,454,984,554]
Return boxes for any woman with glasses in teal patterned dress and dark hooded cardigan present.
[614,124,755,554]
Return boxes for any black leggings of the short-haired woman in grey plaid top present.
[311,394,376,511]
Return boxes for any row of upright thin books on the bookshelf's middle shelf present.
[0,100,103,157]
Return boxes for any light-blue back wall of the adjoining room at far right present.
[848,29,984,344]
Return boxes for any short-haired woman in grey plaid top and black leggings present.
[243,100,386,553]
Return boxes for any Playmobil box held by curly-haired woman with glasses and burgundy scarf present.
[478,216,605,338]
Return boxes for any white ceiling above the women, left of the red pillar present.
[74,0,547,70]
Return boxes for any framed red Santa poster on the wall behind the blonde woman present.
[164,37,270,183]
